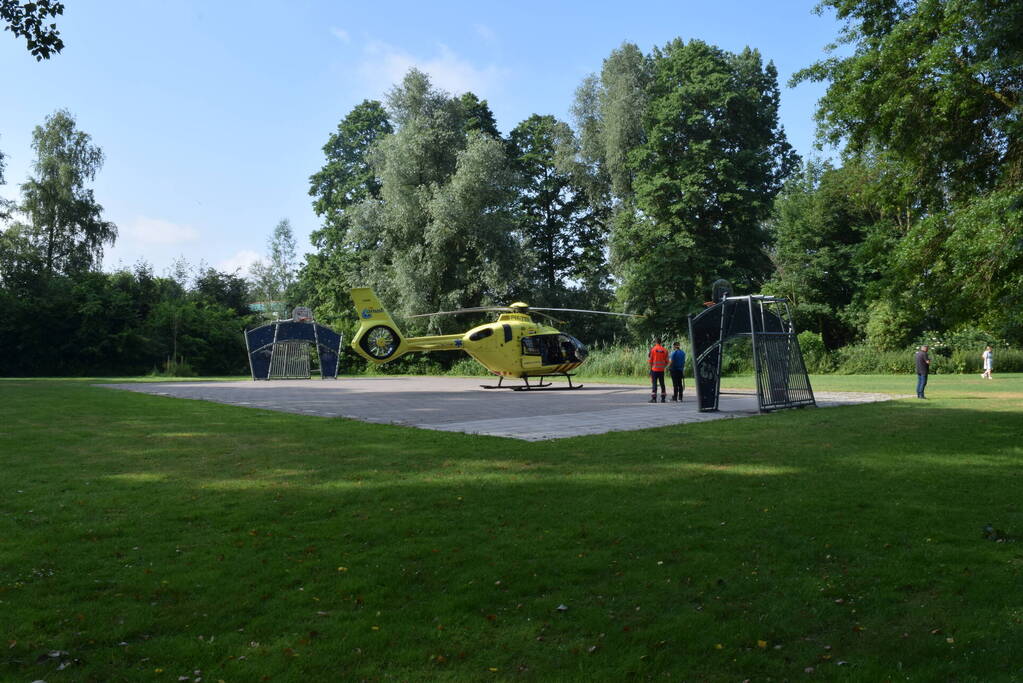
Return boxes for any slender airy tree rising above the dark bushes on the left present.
[20,109,118,274]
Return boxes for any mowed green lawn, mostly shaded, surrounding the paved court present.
[0,375,1023,683]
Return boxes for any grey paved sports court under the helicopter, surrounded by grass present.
[101,377,893,441]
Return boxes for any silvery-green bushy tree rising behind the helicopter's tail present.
[348,70,521,323]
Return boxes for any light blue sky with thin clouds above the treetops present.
[0,0,839,273]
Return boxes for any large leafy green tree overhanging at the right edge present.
[794,0,1023,339]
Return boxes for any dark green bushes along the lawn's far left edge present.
[0,265,256,376]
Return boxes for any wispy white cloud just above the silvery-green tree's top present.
[358,42,507,97]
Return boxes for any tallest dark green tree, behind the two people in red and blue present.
[612,39,797,330]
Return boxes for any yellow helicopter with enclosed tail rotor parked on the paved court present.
[352,287,642,391]
